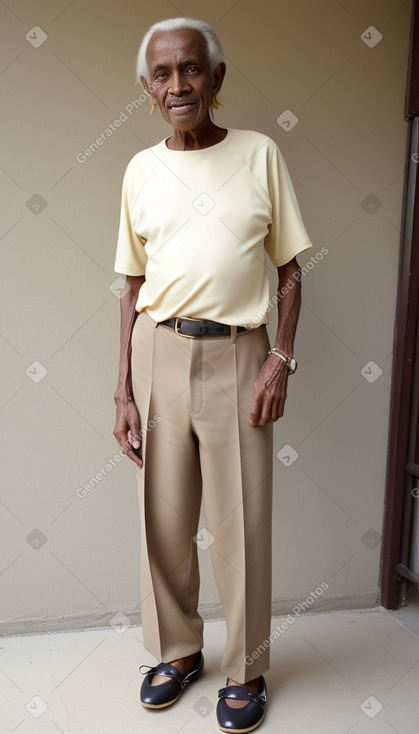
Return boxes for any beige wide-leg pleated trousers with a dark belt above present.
[131,312,272,683]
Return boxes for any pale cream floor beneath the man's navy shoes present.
[0,607,419,734]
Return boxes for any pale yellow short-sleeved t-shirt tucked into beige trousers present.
[115,129,311,327]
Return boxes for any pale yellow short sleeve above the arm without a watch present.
[114,164,147,275]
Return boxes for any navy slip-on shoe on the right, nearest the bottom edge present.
[217,675,266,734]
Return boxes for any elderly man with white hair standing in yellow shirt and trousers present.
[114,18,311,732]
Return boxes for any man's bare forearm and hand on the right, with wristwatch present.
[249,257,301,426]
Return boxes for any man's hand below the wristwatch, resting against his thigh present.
[249,354,288,426]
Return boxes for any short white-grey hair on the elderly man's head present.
[137,18,225,82]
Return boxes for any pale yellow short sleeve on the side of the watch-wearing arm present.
[265,141,312,267]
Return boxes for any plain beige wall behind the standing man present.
[0,0,410,633]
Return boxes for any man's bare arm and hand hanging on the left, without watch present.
[113,275,145,467]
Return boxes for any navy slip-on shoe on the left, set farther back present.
[140,650,204,709]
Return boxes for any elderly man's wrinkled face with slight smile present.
[143,28,223,131]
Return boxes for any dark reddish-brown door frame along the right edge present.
[381,0,419,609]
